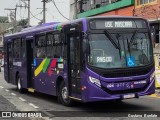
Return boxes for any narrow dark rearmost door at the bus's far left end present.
[7,42,13,83]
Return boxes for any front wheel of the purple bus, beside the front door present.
[58,81,73,107]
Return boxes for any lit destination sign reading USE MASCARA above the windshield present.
[90,19,146,29]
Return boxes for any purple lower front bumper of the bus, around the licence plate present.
[82,79,155,102]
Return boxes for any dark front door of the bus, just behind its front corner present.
[67,31,81,98]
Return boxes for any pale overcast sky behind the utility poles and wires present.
[0,0,69,25]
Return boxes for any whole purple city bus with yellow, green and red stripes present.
[4,16,155,106]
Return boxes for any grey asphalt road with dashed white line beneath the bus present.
[0,68,160,120]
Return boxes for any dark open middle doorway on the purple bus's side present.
[26,39,34,88]
